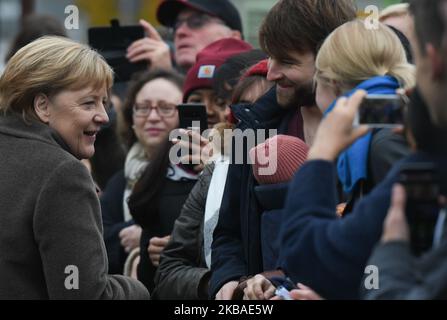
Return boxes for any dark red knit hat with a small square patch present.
[183,38,253,102]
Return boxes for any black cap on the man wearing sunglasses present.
[157,0,242,33]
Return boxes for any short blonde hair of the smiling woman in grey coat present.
[0,36,113,120]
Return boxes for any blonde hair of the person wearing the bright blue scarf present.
[315,20,415,91]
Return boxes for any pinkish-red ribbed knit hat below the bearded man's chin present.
[250,135,309,184]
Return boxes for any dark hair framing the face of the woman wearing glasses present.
[118,69,184,148]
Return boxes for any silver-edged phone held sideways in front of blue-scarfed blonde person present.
[354,94,407,128]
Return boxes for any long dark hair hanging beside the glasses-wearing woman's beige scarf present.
[128,140,172,227]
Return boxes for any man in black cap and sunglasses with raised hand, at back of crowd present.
[127,0,242,71]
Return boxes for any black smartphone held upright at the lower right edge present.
[399,163,442,256]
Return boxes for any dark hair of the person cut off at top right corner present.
[410,0,447,53]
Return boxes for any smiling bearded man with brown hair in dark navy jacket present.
[210,0,355,299]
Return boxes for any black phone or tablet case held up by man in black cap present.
[88,19,147,82]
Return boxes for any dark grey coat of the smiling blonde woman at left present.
[0,115,149,299]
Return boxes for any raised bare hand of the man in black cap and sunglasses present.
[126,20,172,69]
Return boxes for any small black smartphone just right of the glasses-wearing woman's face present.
[177,103,208,134]
